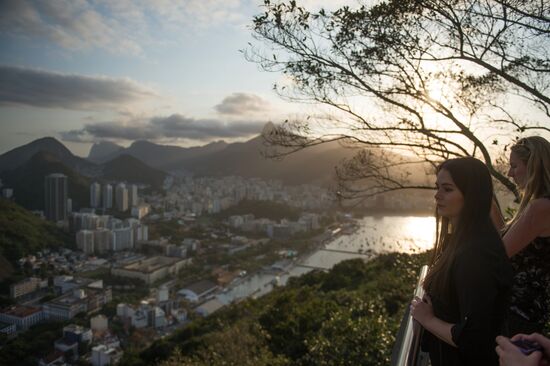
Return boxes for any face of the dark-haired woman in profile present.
[435,169,464,223]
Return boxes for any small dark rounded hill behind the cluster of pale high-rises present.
[102,154,166,189]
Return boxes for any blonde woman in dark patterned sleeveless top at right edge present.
[503,136,550,335]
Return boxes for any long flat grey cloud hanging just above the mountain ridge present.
[61,114,265,142]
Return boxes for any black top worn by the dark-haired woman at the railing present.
[424,230,513,366]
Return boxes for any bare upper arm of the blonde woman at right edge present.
[502,198,550,257]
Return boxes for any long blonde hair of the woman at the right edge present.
[507,136,550,227]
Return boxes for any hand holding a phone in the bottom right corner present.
[495,334,550,366]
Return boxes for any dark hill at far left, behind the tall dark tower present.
[1,151,91,210]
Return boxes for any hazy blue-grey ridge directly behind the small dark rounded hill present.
[91,140,227,171]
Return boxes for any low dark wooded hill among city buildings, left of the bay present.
[214,200,300,221]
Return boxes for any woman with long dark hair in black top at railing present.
[411,157,512,366]
